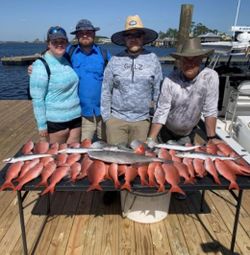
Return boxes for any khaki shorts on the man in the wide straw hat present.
[105,117,150,145]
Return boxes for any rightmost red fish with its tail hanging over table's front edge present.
[215,159,240,190]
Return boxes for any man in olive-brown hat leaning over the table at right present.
[147,38,219,144]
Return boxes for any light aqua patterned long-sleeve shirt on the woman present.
[30,52,81,130]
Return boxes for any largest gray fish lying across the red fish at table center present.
[88,150,165,165]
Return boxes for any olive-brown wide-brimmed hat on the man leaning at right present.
[170,37,214,59]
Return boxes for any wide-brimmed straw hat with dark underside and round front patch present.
[111,15,158,46]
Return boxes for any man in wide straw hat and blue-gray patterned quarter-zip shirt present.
[101,15,162,145]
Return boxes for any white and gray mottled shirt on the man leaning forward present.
[153,68,219,136]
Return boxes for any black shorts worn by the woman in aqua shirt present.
[47,117,82,133]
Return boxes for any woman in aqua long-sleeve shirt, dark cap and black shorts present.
[30,26,81,143]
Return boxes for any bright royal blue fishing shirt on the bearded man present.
[71,44,111,117]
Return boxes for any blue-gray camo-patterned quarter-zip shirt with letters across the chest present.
[101,50,163,122]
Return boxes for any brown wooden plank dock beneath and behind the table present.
[0,100,250,255]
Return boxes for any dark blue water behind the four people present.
[0,43,173,100]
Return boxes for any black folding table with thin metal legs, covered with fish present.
[0,159,250,255]
